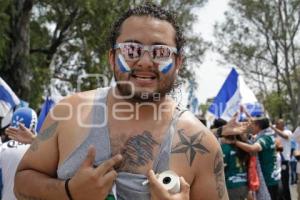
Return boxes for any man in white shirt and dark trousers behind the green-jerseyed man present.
[271,119,293,200]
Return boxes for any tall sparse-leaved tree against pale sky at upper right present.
[215,0,300,126]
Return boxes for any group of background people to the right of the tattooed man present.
[213,116,300,200]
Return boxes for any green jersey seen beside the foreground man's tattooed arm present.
[221,144,247,189]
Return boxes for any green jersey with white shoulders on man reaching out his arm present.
[256,133,280,186]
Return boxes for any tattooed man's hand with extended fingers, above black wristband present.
[69,146,122,200]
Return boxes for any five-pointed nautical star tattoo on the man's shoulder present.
[171,129,209,166]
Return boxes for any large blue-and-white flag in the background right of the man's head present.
[208,68,263,121]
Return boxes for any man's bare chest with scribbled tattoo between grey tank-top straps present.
[110,127,166,173]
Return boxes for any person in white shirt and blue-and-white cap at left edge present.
[0,107,37,200]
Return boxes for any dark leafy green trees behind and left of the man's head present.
[0,0,206,108]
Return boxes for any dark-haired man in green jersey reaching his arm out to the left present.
[234,117,280,200]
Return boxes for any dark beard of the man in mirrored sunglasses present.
[114,70,176,103]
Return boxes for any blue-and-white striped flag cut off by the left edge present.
[0,77,20,117]
